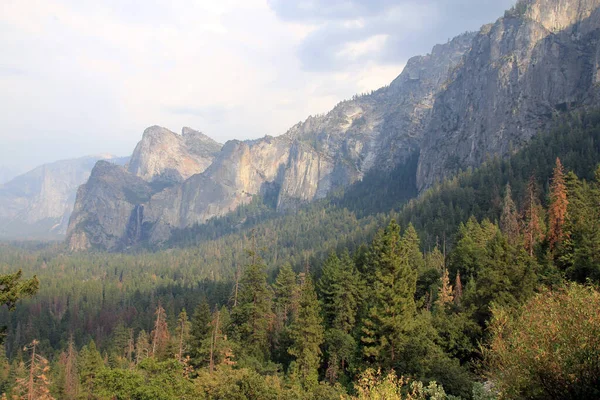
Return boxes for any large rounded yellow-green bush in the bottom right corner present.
[484,284,600,399]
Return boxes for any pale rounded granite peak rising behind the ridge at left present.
[128,126,222,184]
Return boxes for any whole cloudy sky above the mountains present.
[0,0,514,170]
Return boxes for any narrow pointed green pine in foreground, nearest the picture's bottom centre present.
[288,275,324,388]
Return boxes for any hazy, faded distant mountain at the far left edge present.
[0,155,127,238]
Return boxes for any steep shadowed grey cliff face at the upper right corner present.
[417,0,600,190]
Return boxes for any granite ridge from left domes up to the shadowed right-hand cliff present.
[67,34,474,250]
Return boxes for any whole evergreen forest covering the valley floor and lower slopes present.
[0,111,600,400]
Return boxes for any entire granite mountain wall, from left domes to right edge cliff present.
[67,0,600,250]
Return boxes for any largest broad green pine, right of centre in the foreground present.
[361,220,420,368]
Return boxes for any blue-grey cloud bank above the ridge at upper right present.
[269,0,514,71]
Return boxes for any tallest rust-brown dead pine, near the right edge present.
[548,158,569,249]
